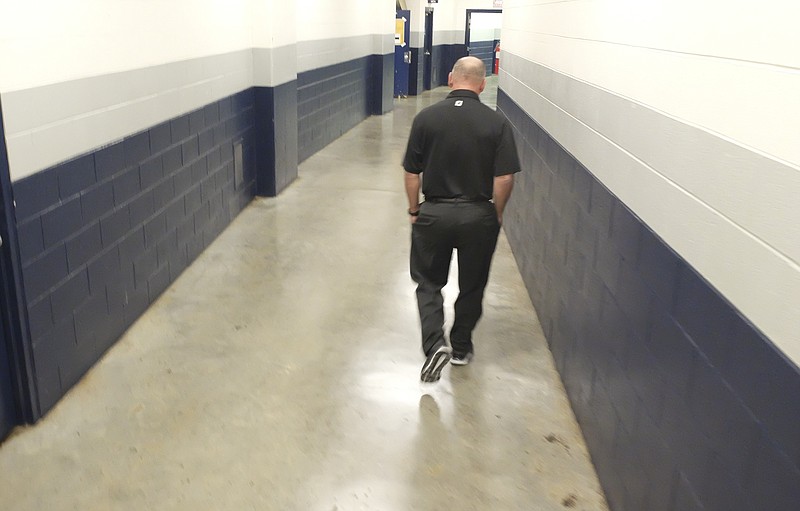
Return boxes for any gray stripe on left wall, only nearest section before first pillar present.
[3,49,253,180]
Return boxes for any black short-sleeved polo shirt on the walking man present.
[403,90,520,200]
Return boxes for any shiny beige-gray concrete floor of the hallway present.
[0,80,607,511]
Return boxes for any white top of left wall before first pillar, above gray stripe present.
[0,0,259,93]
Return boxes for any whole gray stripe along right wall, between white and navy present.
[500,52,800,361]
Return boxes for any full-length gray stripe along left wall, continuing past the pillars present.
[3,34,394,180]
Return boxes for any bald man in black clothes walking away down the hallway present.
[403,57,520,382]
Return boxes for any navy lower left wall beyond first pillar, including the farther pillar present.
[297,54,394,161]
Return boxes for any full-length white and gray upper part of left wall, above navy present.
[0,0,394,180]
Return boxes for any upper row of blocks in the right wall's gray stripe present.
[503,54,800,264]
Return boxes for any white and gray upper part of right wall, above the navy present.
[500,0,800,362]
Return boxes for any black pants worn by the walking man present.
[411,202,500,355]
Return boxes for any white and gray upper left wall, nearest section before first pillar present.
[0,0,277,180]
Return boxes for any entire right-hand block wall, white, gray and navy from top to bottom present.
[498,1,800,511]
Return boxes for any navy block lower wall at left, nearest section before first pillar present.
[13,89,256,414]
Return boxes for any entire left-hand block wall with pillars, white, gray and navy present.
[0,0,393,420]
